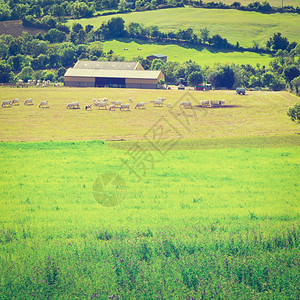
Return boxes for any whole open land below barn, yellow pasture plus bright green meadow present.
[0,88,300,299]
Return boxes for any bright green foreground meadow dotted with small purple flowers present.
[0,140,300,299]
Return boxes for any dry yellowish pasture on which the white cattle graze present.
[0,87,299,141]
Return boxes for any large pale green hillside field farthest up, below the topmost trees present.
[67,7,300,46]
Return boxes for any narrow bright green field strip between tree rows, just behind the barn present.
[103,39,272,66]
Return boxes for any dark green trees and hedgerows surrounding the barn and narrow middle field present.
[0,16,300,91]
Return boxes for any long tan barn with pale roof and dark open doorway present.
[64,61,165,89]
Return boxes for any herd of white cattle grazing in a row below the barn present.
[1,97,225,111]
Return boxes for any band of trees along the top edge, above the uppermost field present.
[0,0,300,21]
